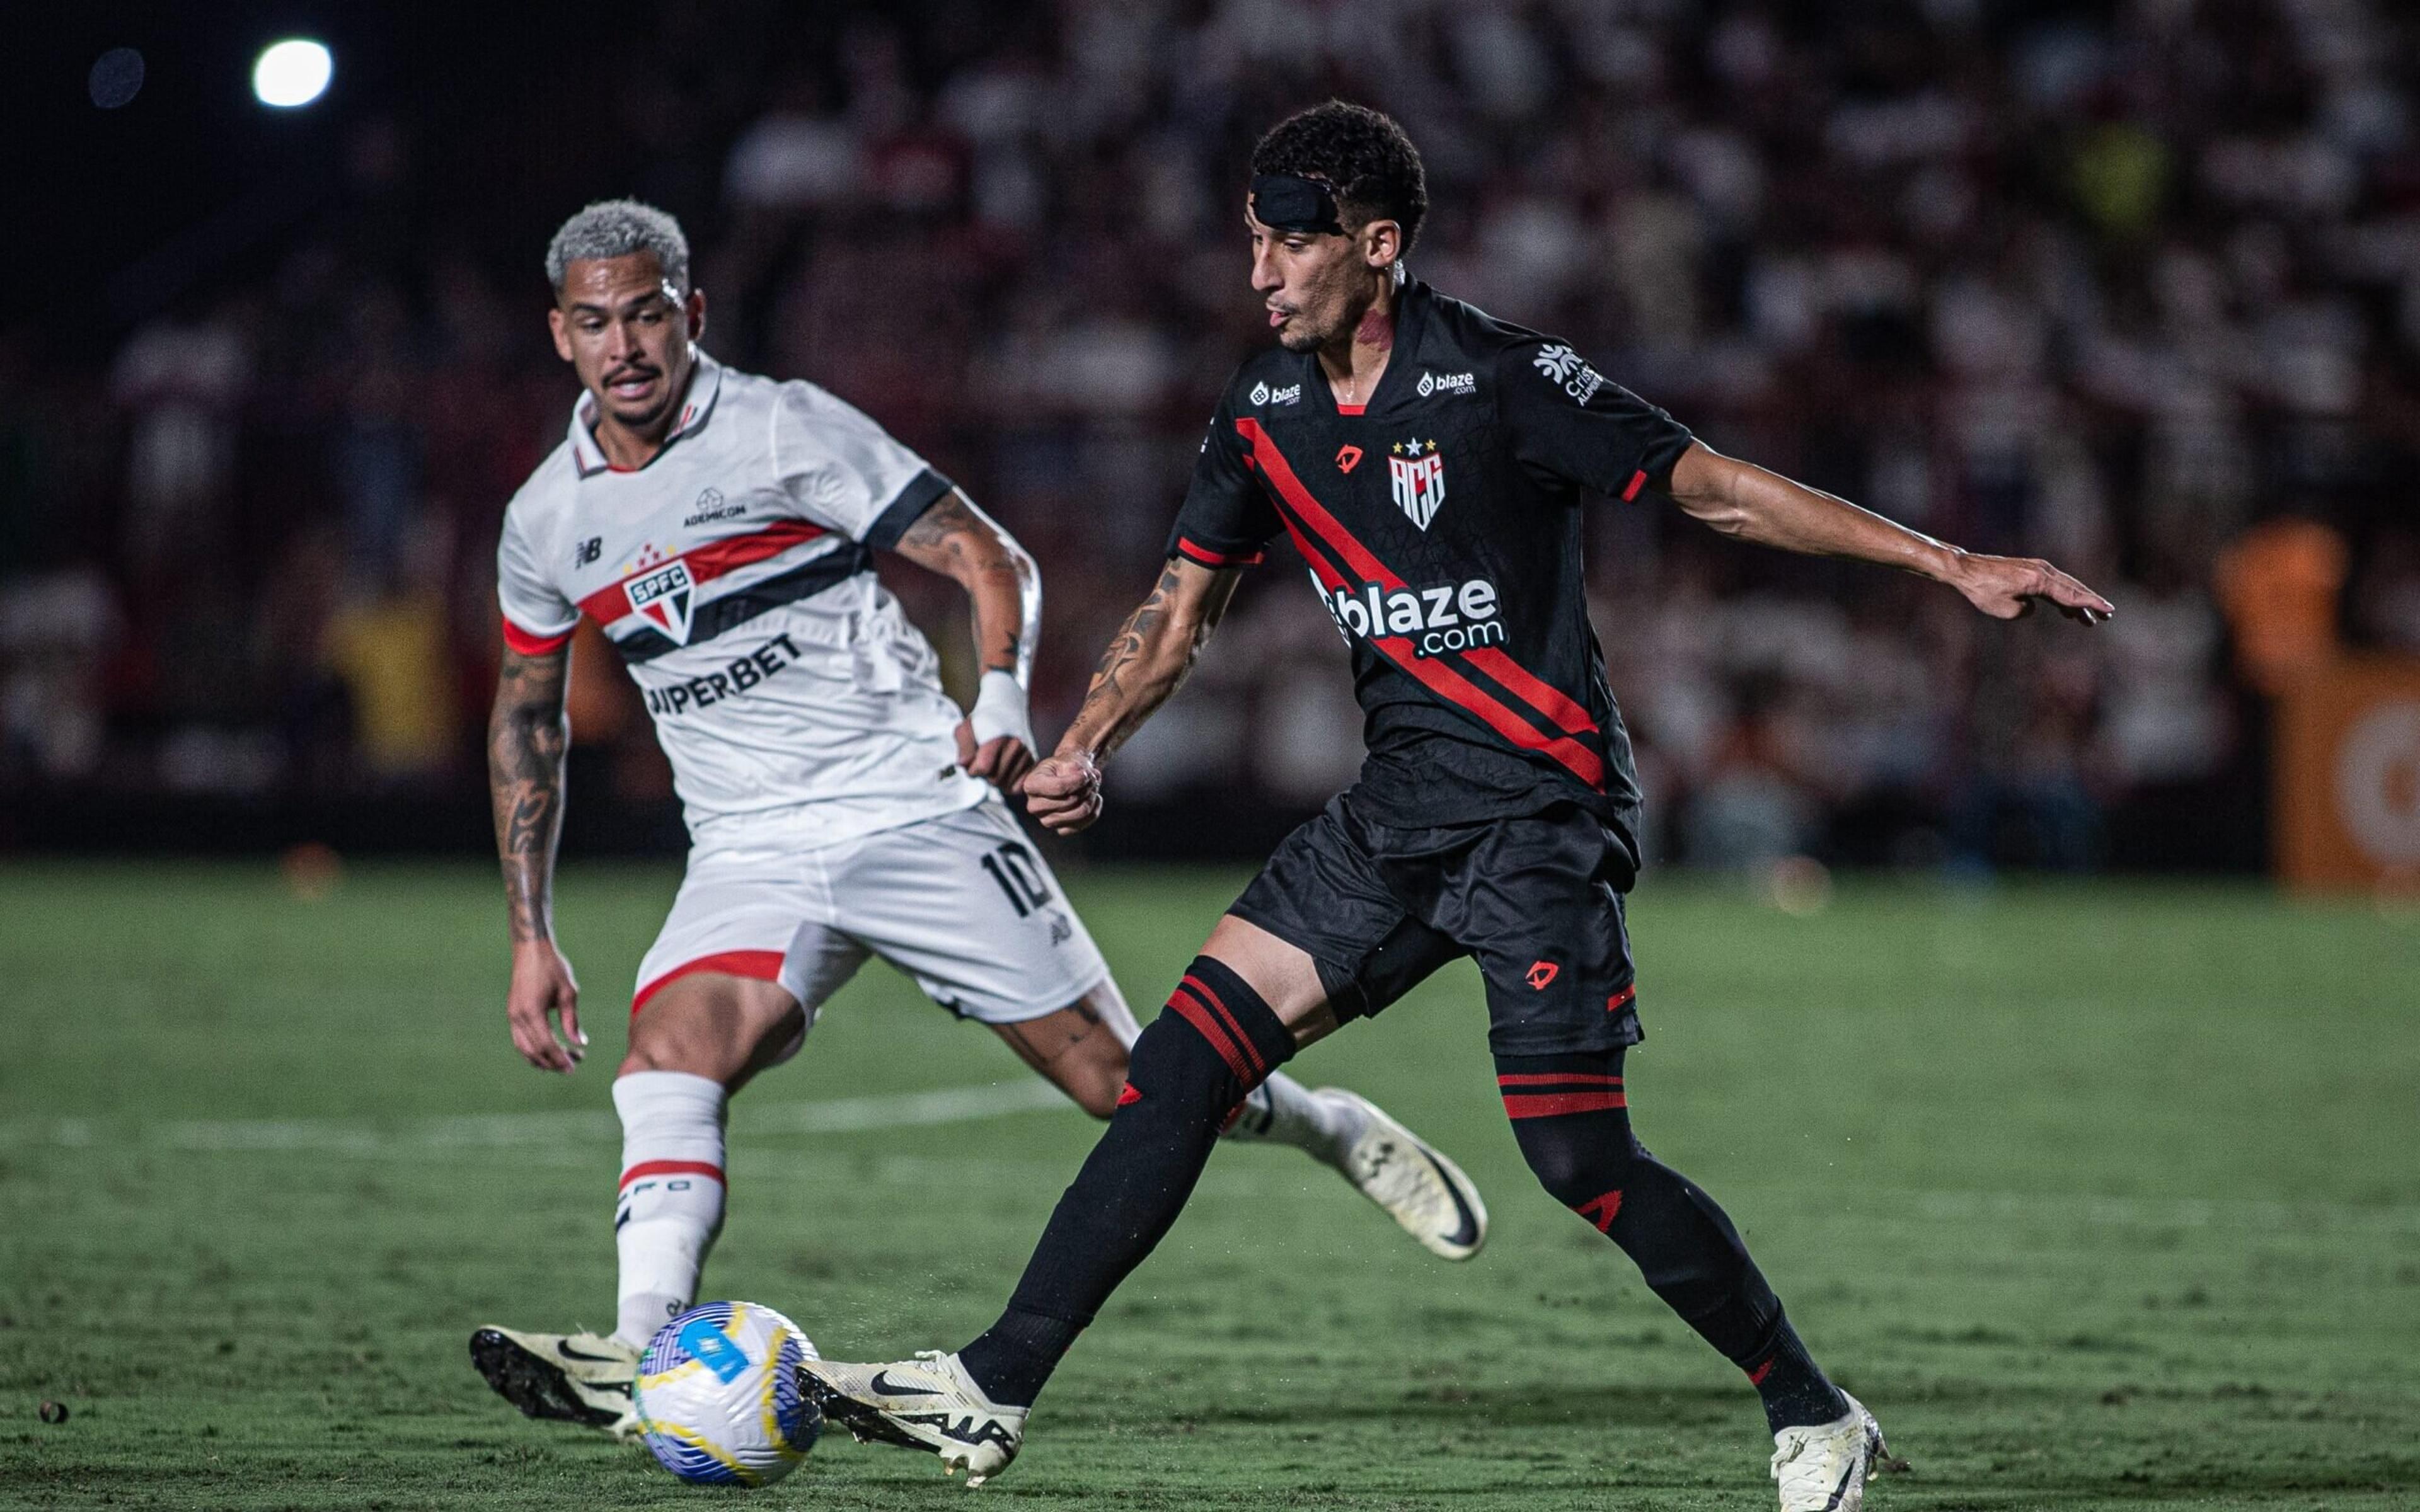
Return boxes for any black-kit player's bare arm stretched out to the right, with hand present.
[1672,443,2118,624]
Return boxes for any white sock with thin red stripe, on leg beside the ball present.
[613,1072,726,1348]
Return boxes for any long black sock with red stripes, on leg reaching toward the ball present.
[959,956,1294,1408]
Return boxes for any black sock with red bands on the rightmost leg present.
[1495,1050,1849,1432]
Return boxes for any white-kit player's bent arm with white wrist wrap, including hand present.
[896,489,1043,794]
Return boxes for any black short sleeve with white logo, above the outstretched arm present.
[1495,336,1691,501]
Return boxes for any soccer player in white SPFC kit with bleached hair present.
[470,201,1486,1432]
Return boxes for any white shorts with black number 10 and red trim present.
[629,798,1109,1023]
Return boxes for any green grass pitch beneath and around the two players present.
[0,866,2420,1512]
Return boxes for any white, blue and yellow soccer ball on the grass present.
[629,1302,823,1486]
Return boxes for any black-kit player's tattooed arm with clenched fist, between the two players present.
[1026,556,1244,835]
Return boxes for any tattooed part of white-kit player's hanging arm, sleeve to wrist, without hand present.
[487,646,571,944]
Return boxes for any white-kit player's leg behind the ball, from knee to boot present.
[470,973,806,1435]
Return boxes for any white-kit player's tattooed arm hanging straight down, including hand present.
[487,646,588,1072]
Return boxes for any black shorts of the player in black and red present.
[1227,794,1641,1055]
